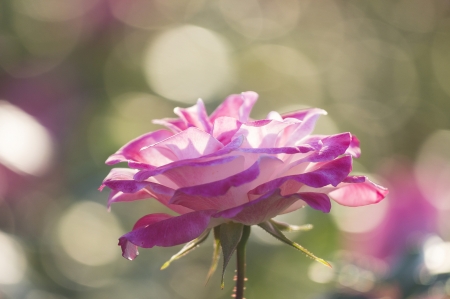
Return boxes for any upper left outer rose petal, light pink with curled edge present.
[106,130,173,165]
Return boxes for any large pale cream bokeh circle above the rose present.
[144,25,234,103]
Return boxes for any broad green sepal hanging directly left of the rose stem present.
[219,222,244,289]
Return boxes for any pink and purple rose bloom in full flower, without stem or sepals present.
[100,92,388,260]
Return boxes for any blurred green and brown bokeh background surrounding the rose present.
[0,0,450,299]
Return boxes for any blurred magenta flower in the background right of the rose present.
[347,157,439,264]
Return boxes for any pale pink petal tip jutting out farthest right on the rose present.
[328,177,389,207]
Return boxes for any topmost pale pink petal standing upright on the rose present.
[210,91,258,123]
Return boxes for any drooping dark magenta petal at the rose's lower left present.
[119,210,215,259]
